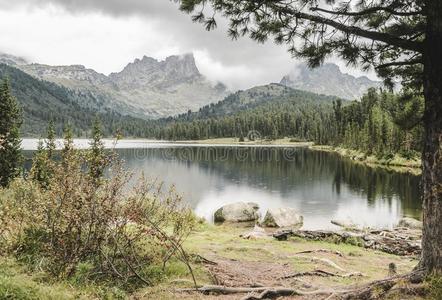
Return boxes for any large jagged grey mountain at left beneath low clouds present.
[0,54,228,118]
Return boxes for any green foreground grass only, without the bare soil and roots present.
[0,224,424,300]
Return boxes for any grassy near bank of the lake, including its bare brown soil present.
[0,224,424,299]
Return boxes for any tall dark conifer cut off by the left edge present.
[0,79,22,187]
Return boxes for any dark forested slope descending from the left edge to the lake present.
[0,64,150,136]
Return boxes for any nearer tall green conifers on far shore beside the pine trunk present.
[332,89,423,159]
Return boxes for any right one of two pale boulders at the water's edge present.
[262,207,304,228]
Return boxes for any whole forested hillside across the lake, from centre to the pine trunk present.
[144,84,423,157]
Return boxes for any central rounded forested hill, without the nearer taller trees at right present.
[142,84,337,144]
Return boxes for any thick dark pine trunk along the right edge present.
[419,0,442,274]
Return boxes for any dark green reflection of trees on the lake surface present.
[115,147,421,216]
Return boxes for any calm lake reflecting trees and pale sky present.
[23,140,421,229]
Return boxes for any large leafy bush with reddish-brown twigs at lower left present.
[0,135,195,288]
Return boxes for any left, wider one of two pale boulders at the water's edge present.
[214,202,260,223]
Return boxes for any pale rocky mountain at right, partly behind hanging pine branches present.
[281,63,382,100]
